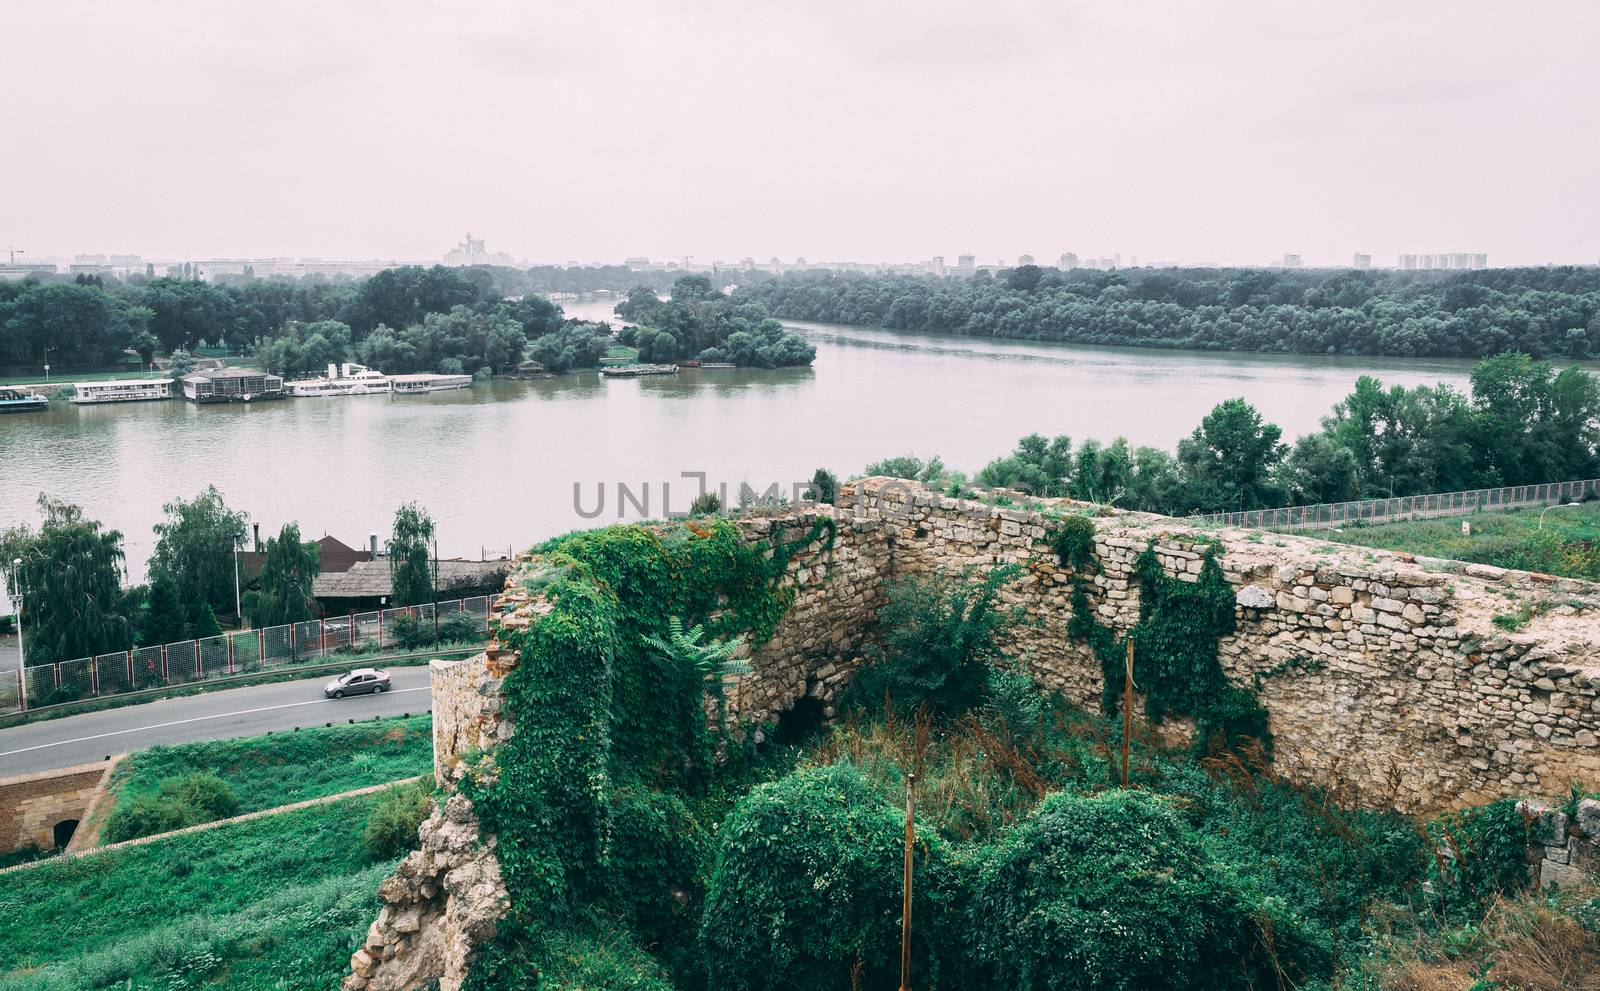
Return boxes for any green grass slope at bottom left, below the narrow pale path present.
[0,794,406,991]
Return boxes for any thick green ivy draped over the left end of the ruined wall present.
[462,517,835,989]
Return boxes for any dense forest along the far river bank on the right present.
[736,266,1600,357]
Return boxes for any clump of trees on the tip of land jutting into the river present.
[616,275,816,368]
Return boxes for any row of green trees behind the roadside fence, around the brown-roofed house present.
[0,496,457,675]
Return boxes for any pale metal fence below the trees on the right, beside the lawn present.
[1190,479,1600,530]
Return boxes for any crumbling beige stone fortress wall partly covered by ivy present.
[344,479,1600,991]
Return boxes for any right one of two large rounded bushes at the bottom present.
[966,791,1293,991]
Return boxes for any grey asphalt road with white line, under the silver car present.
[0,664,432,778]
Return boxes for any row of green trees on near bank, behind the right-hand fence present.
[866,354,1600,516]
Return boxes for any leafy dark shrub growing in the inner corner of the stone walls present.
[853,565,1019,717]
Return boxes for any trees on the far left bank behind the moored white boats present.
[0,266,608,375]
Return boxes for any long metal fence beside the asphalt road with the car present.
[0,596,494,712]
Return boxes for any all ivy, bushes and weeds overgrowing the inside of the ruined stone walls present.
[448,519,1600,991]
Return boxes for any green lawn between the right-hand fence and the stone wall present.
[1301,503,1600,580]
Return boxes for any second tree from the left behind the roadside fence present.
[150,485,250,613]
